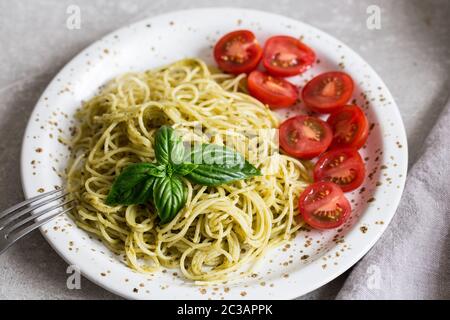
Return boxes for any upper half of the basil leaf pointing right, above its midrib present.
[185,144,245,168]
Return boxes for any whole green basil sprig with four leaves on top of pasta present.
[105,126,261,223]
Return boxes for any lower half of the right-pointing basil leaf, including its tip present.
[186,161,261,187]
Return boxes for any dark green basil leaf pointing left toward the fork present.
[105,163,165,205]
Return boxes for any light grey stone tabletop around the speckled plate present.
[0,0,450,299]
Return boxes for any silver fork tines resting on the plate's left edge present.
[0,189,75,254]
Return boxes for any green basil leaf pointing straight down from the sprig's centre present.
[153,175,187,224]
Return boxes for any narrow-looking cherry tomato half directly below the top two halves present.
[247,70,298,109]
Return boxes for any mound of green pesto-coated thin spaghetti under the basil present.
[67,59,311,284]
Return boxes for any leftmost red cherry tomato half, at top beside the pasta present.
[214,30,262,74]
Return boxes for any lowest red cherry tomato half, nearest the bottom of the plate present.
[298,182,351,229]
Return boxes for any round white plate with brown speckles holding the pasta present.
[21,8,407,299]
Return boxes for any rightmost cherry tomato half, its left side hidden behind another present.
[327,105,369,149]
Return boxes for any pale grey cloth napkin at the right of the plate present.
[337,100,450,299]
